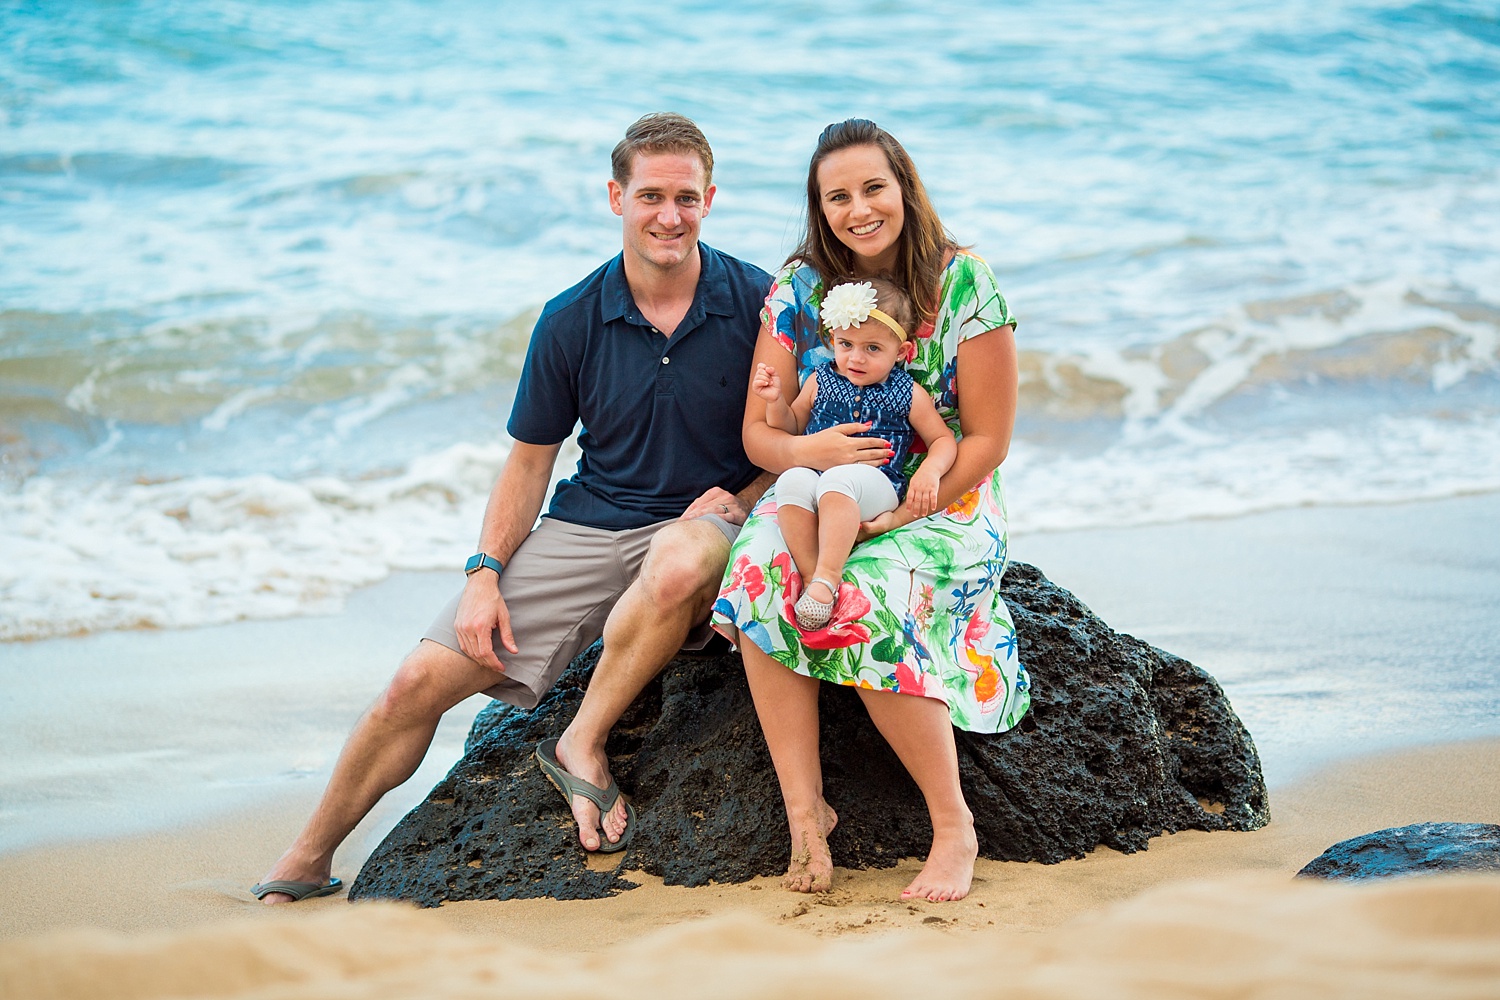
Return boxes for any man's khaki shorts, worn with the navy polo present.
[422,514,740,708]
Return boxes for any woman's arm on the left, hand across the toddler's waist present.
[741,327,891,474]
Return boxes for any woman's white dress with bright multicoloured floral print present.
[714,252,1031,733]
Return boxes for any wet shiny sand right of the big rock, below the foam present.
[1011,493,1500,784]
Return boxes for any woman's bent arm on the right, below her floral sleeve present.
[860,324,1019,541]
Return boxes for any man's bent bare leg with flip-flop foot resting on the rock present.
[557,520,729,850]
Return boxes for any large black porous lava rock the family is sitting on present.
[350,562,1269,906]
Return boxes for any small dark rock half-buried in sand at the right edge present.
[1298,823,1500,880]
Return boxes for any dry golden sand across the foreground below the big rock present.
[0,741,1500,997]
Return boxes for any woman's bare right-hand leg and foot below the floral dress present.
[860,688,980,903]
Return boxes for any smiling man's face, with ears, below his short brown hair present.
[609,153,714,270]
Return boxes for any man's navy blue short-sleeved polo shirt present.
[507,243,771,531]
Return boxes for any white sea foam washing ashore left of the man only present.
[0,444,507,639]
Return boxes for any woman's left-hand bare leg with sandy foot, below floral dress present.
[738,642,839,892]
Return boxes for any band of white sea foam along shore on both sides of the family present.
[0,395,1500,640]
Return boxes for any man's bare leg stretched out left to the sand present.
[261,640,510,904]
